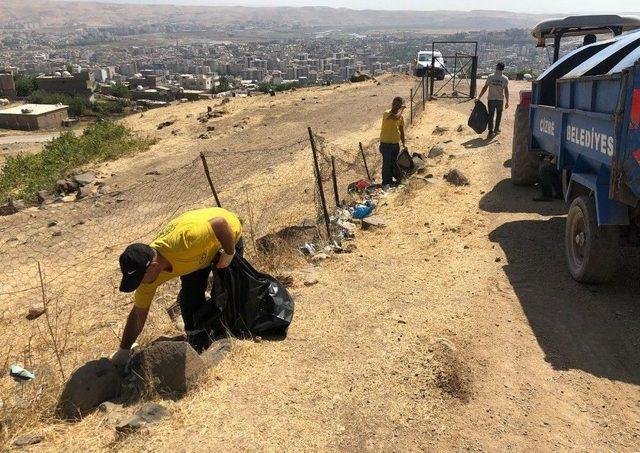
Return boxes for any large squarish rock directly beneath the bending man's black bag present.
[129,341,207,398]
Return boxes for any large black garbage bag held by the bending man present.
[214,254,294,337]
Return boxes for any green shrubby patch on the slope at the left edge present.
[0,120,153,202]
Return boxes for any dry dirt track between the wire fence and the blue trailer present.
[2,77,640,451]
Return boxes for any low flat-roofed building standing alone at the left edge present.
[0,104,69,131]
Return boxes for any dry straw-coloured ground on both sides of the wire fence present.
[0,77,640,451]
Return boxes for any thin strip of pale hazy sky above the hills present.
[70,0,640,14]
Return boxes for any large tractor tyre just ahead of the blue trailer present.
[511,105,539,186]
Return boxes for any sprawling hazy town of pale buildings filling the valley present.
[0,24,546,108]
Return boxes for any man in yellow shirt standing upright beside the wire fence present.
[380,97,406,189]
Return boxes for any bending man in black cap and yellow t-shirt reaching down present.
[111,208,242,367]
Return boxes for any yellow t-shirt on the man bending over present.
[135,208,242,308]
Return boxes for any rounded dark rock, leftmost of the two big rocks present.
[56,358,122,420]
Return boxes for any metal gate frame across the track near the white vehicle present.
[427,41,478,99]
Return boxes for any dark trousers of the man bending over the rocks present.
[178,238,244,352]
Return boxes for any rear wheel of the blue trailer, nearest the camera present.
[564,195,620,283]
